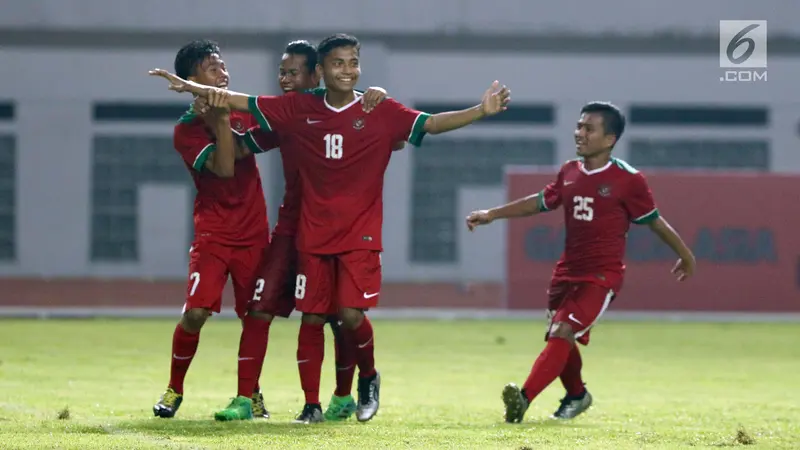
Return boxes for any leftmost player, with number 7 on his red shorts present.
[153,40,277,417]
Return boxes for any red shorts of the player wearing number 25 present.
[545,280,616,345]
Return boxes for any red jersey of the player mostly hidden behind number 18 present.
[245,127,301,236]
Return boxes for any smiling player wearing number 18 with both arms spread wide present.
[150,34,510,423]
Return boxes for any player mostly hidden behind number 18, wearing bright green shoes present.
[206,41,394,420]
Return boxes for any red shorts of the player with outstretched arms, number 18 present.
[295,250,381,314]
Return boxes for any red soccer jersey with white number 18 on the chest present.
[250,89,429,254]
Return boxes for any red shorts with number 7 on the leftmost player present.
[183,236,269,317]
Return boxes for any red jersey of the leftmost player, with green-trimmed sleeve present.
[173,110,276,246]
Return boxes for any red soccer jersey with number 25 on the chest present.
[539,158,659,289]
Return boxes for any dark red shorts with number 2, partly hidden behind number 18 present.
[249,235,297,317]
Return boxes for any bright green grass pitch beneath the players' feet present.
[0,320,800,449]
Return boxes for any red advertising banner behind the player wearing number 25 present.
[506,168,800,312]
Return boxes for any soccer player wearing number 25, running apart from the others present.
[467,102,695,423]
